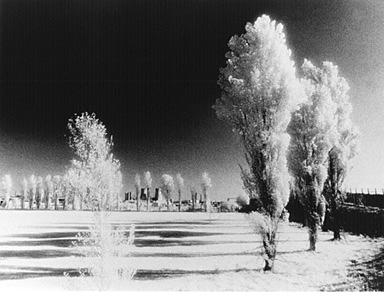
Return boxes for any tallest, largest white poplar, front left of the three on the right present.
[214,15,305,270]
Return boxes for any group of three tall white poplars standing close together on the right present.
[214,15,358,270]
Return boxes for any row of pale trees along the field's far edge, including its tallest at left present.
[2,113,216,211]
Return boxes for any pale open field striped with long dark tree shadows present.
[0,210,384,291]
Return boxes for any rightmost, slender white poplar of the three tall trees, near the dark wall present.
[323,62,359,240]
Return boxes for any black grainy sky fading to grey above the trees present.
[0,0,384,197]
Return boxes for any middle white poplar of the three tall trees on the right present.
[289,60,337,250]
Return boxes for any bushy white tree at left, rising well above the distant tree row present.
[68,113,120,210]
